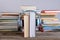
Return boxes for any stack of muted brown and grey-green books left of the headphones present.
[0,13,19,31]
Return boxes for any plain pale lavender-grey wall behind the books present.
[0,0,60,12]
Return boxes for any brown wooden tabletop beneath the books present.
[0,32,60,40]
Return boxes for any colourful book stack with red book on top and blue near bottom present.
[40,10,60,31]
